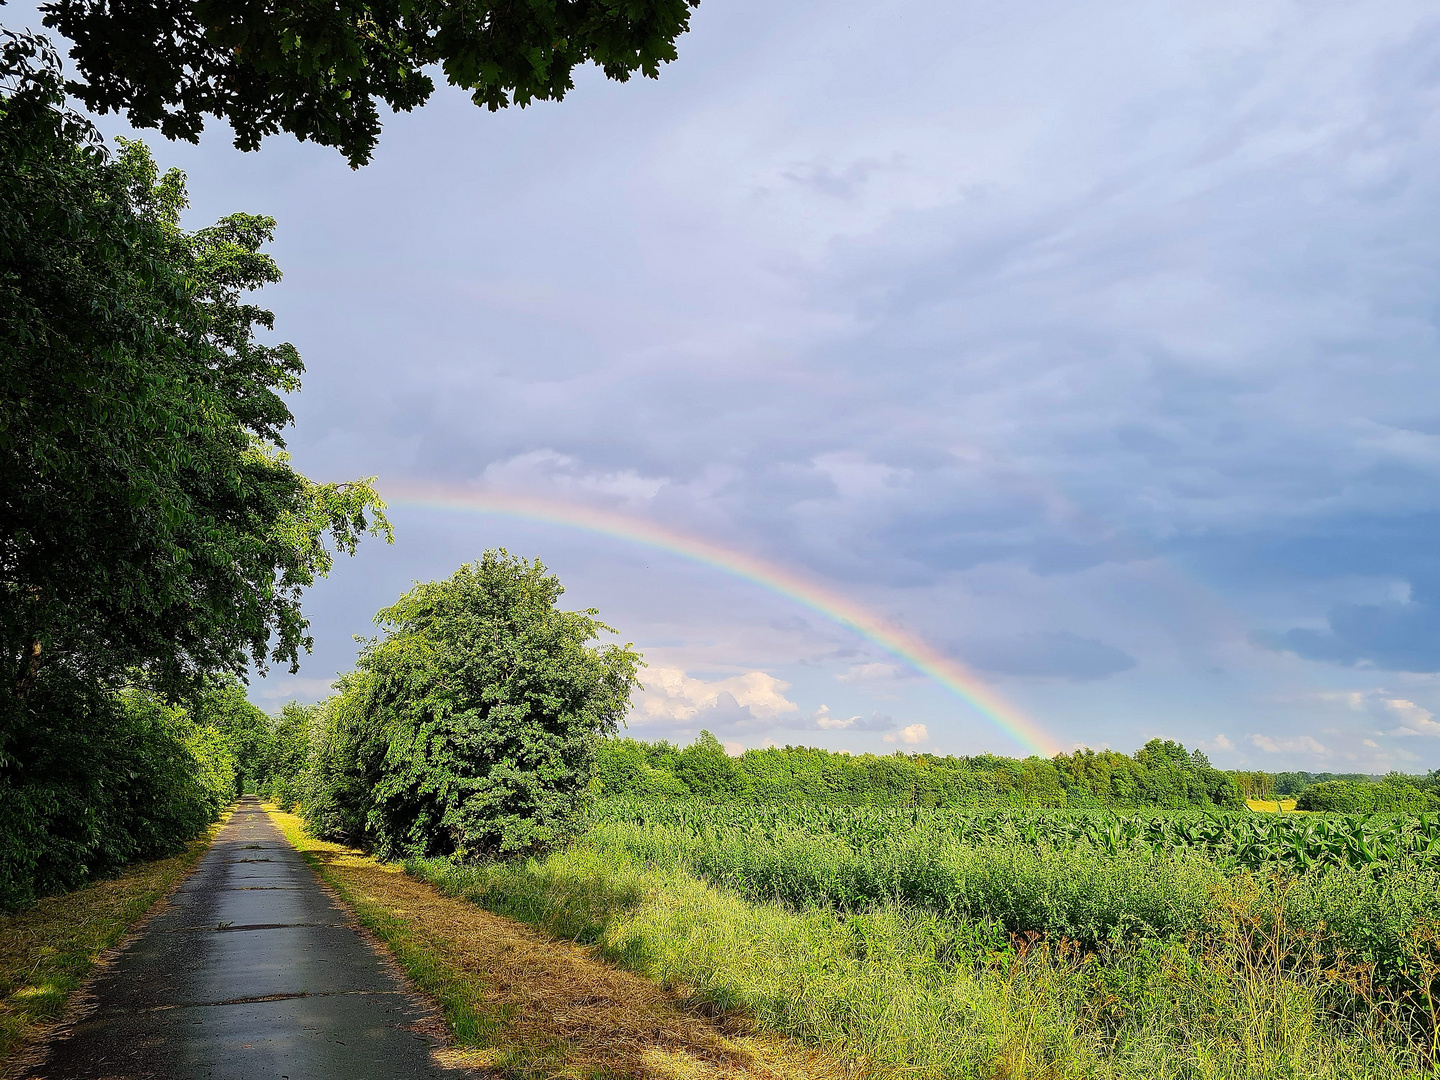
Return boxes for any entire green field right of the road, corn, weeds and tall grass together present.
[420,799,1440,1080]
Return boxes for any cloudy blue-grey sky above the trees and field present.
[16,0,1440,772]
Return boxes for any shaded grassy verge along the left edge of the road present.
[0,818,223,1076]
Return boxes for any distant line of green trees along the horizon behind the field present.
[596,732,1440,814]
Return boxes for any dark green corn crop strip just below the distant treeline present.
[595,799,1440,873]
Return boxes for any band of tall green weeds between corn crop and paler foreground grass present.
[570,808,1440,994]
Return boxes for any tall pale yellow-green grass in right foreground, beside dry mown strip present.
[408,838,1434,1080]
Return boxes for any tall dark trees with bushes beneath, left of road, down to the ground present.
[0,32,389,906]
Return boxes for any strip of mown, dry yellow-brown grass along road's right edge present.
[271,811,847,1080]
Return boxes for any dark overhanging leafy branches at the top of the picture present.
[42,0,698,166]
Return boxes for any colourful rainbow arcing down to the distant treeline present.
[390,485,1060,757]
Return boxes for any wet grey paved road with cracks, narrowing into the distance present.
[32,798,464,1080]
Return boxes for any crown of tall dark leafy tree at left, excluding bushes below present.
[0,33,389,711]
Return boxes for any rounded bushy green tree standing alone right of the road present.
[305,550,641,858]
